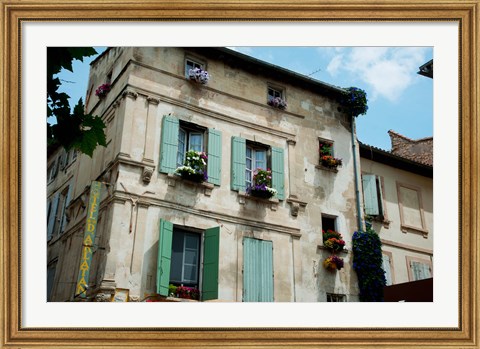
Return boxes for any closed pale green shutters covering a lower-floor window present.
[243,238,273,302]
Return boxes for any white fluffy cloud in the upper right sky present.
[327,47,427,102]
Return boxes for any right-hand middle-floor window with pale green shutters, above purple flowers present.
[230,137,285,200]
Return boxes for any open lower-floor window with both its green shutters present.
[157,219,220,300]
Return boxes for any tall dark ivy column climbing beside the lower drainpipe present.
[352,222,386,302]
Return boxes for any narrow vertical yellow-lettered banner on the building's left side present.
[75,181,102,298]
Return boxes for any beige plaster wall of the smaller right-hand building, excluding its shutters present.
[361,157,434,284]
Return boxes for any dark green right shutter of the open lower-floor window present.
[202,227,220,301]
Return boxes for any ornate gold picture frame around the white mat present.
[0,0,480,348]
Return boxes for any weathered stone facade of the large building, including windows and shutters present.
[48,47,368,302]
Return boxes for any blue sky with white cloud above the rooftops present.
[59,46,433,150]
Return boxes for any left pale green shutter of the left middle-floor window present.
[158,115,180,173]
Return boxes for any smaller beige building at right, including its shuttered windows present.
[360,139,433,288]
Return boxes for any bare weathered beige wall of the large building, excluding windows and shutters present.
[49,48,364,302]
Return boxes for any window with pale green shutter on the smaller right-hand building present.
[362,174,386,220]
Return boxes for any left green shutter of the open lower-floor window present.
[157,219,173,296]
